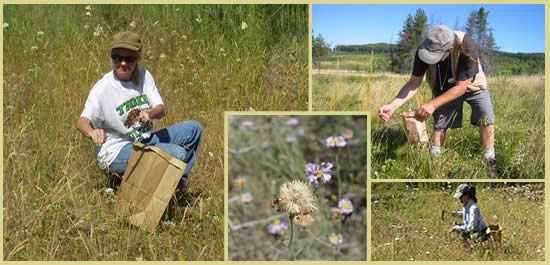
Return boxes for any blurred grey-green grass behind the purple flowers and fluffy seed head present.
[228,115,368,261]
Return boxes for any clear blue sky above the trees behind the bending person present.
[312,4,545,52]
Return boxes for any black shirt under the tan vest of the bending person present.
[413,34,479,91]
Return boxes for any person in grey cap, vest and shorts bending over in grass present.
[378,25,497,177]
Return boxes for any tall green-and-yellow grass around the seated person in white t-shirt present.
[3,5,309,261]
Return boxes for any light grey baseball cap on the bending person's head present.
[418,25,455,64]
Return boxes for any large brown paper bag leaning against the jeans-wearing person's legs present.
[116,141,187,233]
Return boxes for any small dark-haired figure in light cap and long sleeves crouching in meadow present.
[449,184,488,241]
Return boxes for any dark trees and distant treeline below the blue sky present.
[312,7,544,75]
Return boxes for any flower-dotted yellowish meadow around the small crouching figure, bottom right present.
[371,182,545,261]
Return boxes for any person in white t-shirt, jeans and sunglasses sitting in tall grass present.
[77,31,202,188]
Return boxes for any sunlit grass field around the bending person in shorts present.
[313,70,544,179]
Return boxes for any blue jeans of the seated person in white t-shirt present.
[109,121,202,188]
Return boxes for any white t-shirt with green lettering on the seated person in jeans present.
[80,69,164,169]
